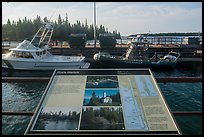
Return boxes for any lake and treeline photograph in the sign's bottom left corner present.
[34,107,80,130]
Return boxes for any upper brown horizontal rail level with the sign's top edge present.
[2,77,202,83]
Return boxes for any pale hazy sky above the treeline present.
[2,2,202,36]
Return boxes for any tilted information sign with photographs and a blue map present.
[25,69,180,134]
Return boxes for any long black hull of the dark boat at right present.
[97,56,176,69]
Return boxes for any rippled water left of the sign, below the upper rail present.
[2,83,46,135]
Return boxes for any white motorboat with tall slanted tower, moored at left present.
[2,22,90,70]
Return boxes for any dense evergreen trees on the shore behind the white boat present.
[2,14,120,41]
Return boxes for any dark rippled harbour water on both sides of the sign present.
[2,64,202,135]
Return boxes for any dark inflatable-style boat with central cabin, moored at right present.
[93,36,180,69]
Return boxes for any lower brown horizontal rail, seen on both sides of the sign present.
[1,111,202,116]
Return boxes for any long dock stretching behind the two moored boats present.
[2,44,202,64]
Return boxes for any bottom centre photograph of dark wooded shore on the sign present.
[80,107,125,130]
